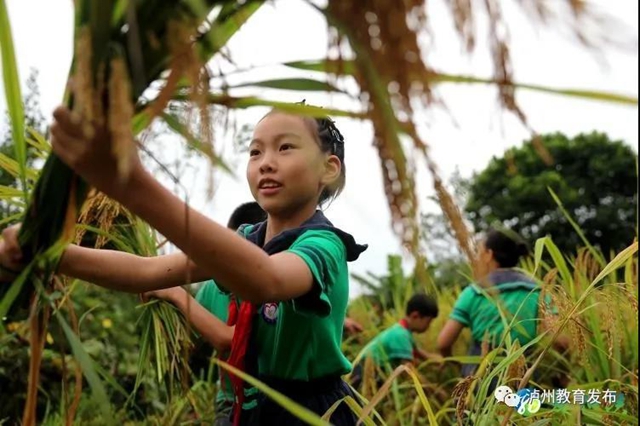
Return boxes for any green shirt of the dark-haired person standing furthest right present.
[450,282,540,345]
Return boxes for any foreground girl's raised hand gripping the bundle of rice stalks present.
[51,107,142,200]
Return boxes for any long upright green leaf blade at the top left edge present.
[0,0,28,201]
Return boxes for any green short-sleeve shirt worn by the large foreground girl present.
[254,230,351,381]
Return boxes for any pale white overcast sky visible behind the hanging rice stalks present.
[0,0,638,296]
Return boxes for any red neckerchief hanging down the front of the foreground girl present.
[227,297,256,426]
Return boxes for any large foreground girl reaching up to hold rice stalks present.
[0,108,366,425]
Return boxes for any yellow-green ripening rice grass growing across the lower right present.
[347,239,638,425]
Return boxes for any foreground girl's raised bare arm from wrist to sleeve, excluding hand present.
[120,169,313,303]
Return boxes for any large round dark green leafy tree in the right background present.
[466,132,638,254]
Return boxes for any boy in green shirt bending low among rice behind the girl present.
[352,294,438,388]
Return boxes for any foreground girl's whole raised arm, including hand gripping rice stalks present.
[51,108,322,303]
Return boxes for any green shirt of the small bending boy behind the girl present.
[364,324,416,367]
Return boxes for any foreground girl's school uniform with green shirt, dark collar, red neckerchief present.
[222,211,367,426]
